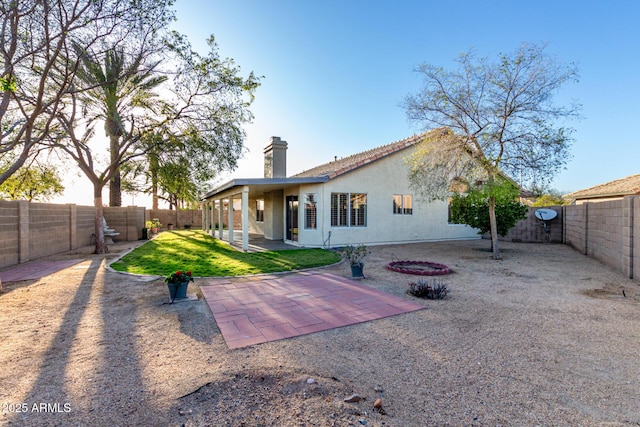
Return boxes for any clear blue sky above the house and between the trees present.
[174,0,640,192]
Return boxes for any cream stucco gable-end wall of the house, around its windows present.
[289,150,480,247]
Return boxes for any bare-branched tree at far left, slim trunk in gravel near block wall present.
[0,0,172,252]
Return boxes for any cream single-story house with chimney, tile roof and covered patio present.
[203,129,479,251]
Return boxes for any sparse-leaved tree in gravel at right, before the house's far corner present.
[402,43,579,259]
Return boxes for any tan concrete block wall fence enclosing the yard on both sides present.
[0,200,640,280]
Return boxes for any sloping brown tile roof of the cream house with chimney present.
[293,128,447,179]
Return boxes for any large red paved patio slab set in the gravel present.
[200,272,425,349]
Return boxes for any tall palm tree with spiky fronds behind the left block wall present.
[78,48,167,206]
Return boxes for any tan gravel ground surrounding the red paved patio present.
[0,240,640,426]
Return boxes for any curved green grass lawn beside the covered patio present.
[111,230,340,277]
